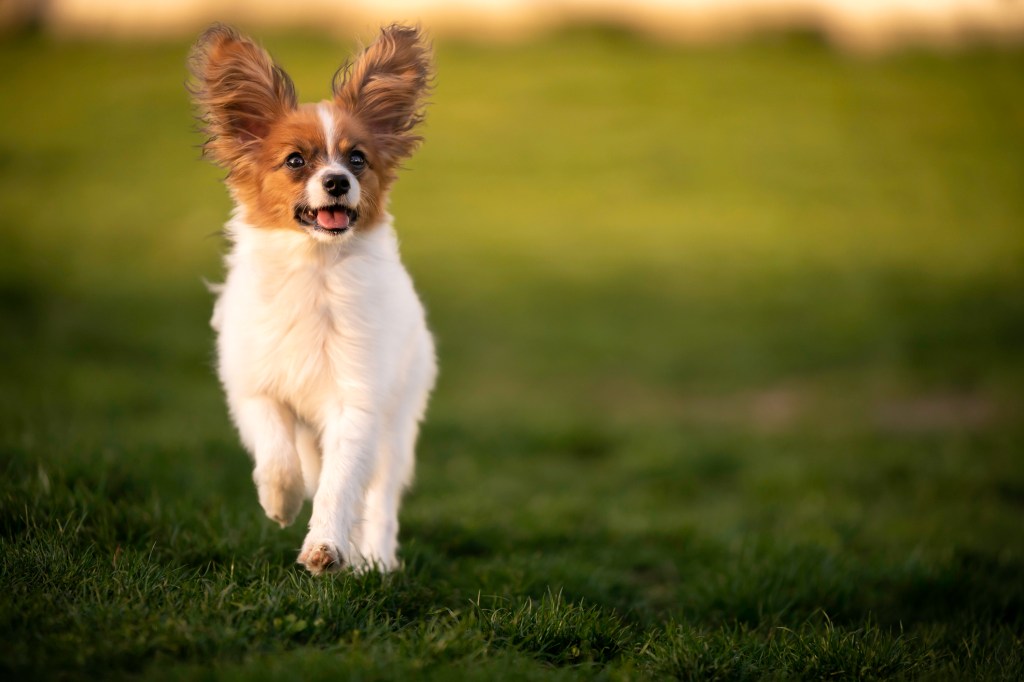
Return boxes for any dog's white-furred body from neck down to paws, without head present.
[212,209,436,572]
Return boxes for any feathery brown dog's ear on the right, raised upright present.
[334,25,433,162]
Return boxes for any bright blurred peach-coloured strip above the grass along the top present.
[6,0,1024,49]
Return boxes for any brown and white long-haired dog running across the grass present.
[187,25,437,574]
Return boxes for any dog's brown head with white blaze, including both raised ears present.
[190,26,430,242]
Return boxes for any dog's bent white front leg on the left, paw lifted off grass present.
[230,396,304,527]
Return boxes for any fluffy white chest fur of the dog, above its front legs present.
[213,218,408,424]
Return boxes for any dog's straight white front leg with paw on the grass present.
[299,407,379,574]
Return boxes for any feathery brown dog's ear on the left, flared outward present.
[187,24,297,168]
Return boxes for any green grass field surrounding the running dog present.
[0,25,1024,680]
